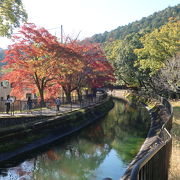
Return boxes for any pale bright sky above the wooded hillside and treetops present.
[0,0,180,48]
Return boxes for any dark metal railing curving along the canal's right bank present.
[130,98,173,180]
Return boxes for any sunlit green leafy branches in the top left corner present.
[0,0,27,37]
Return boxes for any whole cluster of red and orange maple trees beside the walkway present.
[3,24,115,102]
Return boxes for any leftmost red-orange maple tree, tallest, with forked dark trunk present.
[3,24,78,103]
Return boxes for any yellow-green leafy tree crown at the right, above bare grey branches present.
[135,21,180,74]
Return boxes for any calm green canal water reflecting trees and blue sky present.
[0,100,149,180]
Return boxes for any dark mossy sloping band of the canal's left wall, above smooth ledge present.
[0,98,114,153]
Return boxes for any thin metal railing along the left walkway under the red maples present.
[0,92,107,115]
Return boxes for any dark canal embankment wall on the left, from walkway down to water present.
[0,95,114,163]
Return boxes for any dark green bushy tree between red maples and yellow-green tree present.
[104,33,142,86]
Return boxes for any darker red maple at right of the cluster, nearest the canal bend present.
[50,41,115,101]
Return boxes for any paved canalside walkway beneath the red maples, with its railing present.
[0,93,105,118]
